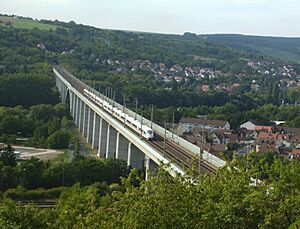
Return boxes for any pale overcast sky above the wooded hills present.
[0,0,300,37]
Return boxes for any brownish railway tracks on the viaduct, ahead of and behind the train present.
[56,66,217,173]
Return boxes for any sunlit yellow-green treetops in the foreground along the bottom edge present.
[0,154,300,228]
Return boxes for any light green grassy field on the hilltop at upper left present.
[0,16,59,30]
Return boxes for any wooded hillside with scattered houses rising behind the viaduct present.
[0,15,300,127]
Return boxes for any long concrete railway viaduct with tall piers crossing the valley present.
[53,65,225,176]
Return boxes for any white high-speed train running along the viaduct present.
[84,89,154,140]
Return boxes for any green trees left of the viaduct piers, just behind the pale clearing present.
[0,103,78,150]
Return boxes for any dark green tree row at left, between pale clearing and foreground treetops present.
[0,145,130,193]
